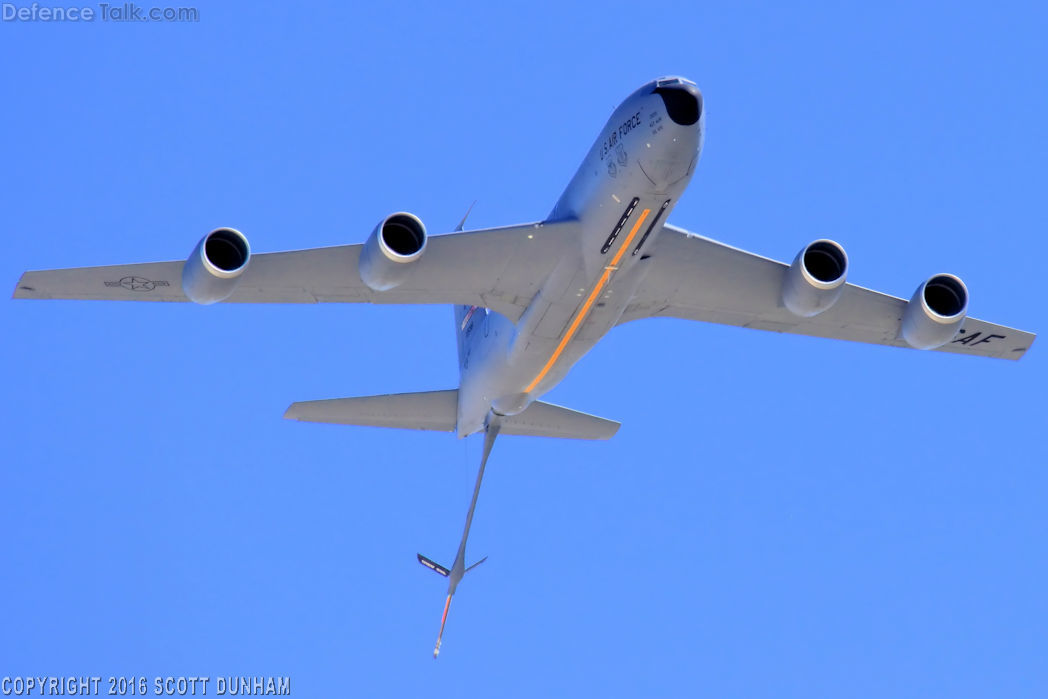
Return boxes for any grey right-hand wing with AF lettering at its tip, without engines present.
[619,224,1035,359]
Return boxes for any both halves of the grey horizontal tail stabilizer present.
[284,390,619,439]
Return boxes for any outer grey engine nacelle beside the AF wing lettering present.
[901,275,968,349]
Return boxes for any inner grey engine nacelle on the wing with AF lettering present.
[783,239,848,318]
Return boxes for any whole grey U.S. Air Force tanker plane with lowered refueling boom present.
[15,77,1034,657]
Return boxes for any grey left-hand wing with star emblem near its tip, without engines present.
[14,221,577,321]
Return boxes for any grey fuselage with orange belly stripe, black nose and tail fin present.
[458,78,705,436]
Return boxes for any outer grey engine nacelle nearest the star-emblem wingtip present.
[182,228,252,305]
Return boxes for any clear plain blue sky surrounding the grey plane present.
[0,2,1048,698]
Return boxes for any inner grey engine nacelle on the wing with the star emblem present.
[359,212,427,291]
